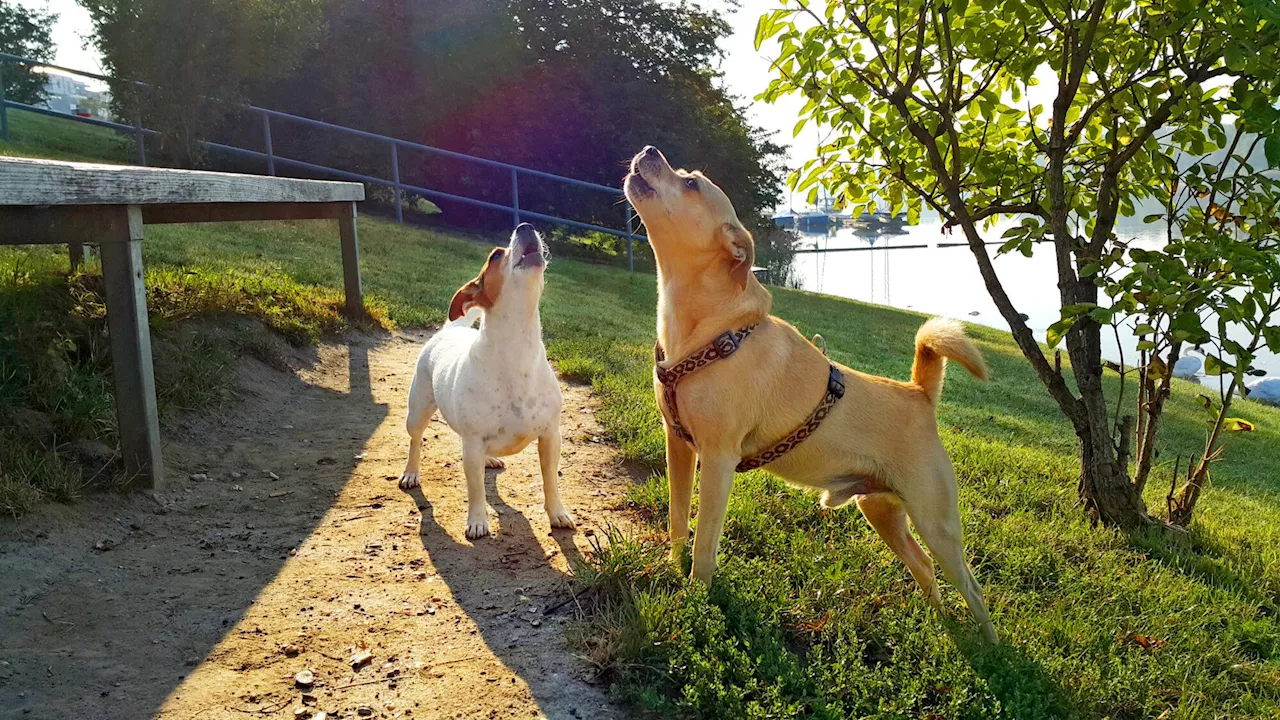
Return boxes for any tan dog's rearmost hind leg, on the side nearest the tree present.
[896,461,997,644]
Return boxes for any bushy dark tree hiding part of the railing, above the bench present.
[77,0,324,165]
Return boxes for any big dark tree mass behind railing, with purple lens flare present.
[247,0,782,238]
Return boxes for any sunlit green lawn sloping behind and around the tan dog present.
[0,127,1280,719]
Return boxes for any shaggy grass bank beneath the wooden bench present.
[0,247,390,516]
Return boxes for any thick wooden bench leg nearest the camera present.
[99,205,164,489]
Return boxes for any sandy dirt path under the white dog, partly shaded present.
[0,334,630,720]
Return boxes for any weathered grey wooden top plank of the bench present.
[0,158,365,205]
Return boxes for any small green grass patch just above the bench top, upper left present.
[0,109,134,163]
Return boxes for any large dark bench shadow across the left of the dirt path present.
[0,334,388,720]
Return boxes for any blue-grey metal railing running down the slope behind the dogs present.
[0,53,646,270]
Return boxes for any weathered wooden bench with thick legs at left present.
[0,158,365,489]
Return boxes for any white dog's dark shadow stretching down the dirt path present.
[407,461,612,717]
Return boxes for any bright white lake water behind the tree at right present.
[792,215,1280,386]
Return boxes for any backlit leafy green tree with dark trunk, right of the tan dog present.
[756,0,1280,528]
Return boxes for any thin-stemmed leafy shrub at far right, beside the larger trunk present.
[1098,127,1280,527]
